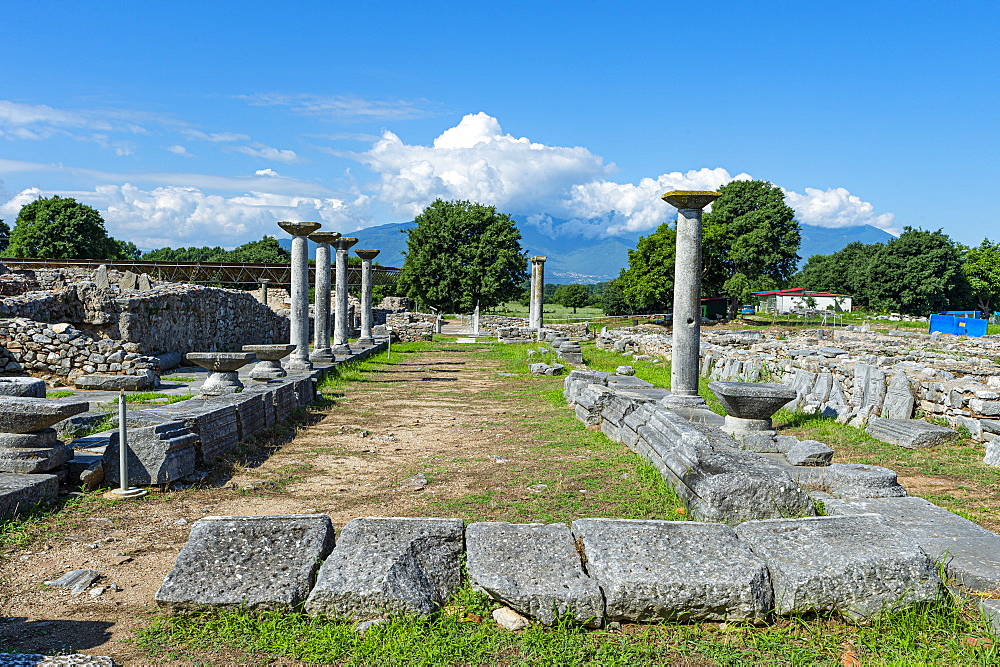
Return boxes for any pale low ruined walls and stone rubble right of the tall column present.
[597,327,1000,465]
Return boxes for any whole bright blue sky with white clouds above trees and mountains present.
[0,0,1000,249]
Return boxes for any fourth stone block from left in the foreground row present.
[572,519,772,621]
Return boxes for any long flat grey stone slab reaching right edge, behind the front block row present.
[824,497,1000,591]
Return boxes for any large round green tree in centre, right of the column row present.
[396,199,528,312]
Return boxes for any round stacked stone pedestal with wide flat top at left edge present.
[0,397,88,473]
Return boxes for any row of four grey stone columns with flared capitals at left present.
[278,222,379,370]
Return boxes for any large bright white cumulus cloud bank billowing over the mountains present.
[354,112,894,237]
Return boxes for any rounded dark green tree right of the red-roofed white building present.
[865,227,971,315]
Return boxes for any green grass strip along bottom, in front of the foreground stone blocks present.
[136,588,1000,667]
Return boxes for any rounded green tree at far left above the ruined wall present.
[3,196,121,259]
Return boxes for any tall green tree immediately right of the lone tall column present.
[702,176,801,316]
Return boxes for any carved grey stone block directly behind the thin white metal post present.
[102,421,198,486]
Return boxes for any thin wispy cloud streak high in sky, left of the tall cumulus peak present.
[236,93,435,120]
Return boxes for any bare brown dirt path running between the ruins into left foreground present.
[0,345,596,664]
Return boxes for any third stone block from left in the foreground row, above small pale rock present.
[465,522,604,627]
